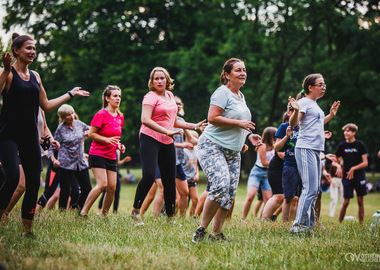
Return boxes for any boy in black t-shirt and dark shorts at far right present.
[335,123,368,223]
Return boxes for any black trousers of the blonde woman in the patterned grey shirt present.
[59,168,92,210]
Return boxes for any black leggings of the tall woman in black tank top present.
[0,139,41,220]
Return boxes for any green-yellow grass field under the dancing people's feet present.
[0,170,380,269]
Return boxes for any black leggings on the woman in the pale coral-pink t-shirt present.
[133,133,176,217]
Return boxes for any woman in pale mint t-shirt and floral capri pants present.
[192,58,260,243]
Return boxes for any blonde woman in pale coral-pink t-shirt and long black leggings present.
[131,67,205,226]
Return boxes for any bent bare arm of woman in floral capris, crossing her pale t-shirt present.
[208,105,255,132]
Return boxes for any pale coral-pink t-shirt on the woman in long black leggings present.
[140,91,178,144]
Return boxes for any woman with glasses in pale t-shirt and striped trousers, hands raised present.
[289,74,340,234]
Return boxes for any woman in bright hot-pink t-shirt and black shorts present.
[79,85,125,216]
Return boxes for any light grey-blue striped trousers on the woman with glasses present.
[292,148,321,230]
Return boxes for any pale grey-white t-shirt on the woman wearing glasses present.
[296,97,325,151]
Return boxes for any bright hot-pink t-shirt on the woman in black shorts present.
[89,109,124,160]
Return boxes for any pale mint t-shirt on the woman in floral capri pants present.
[203,85,251,151]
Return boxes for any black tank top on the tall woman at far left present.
[0,66,40,141]
